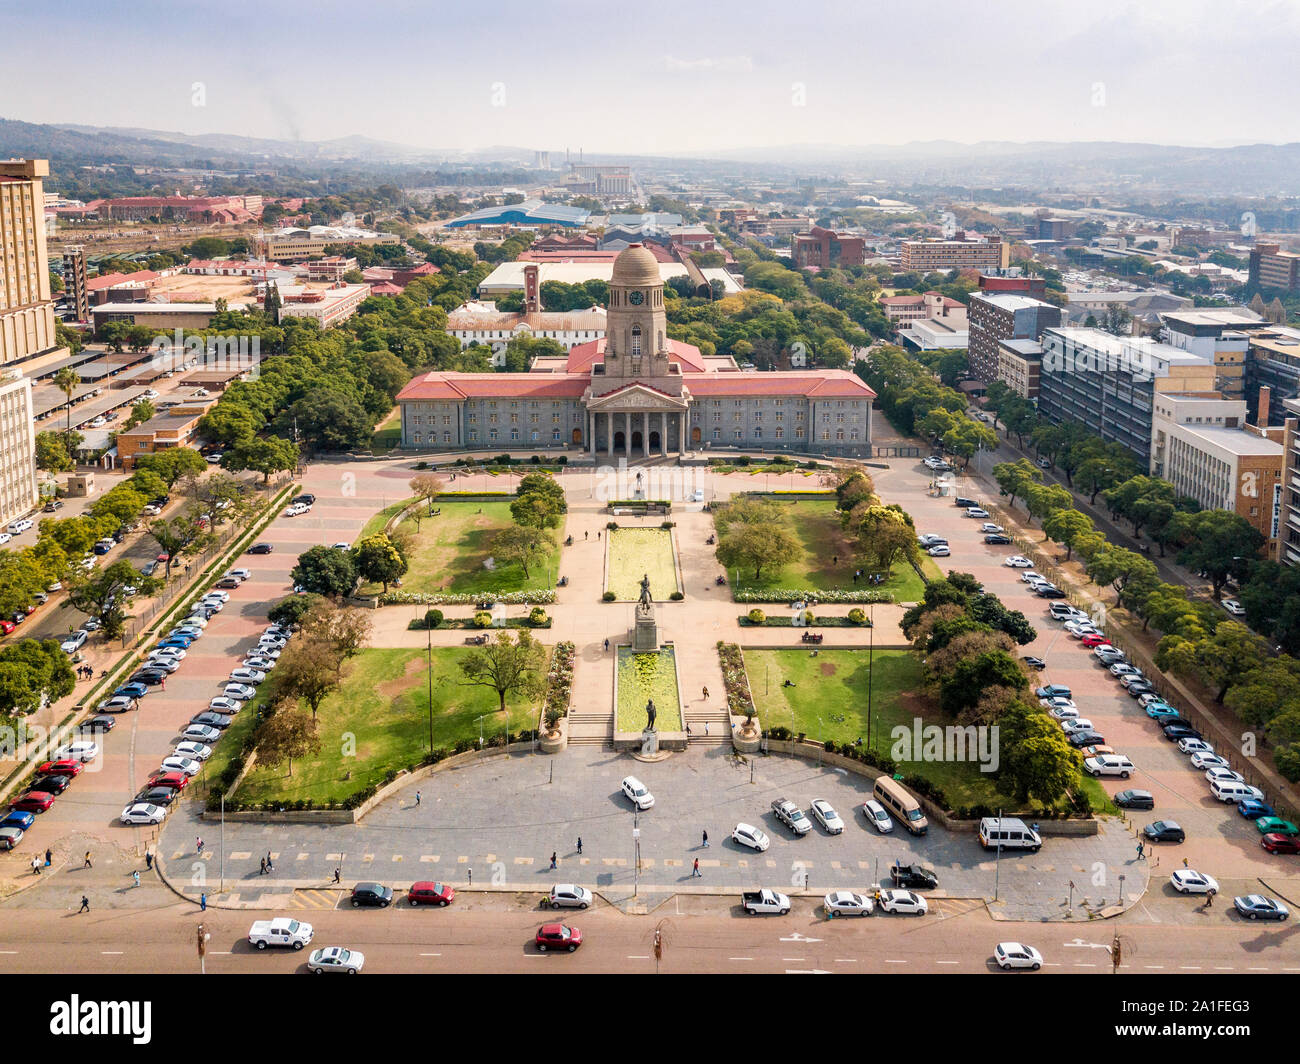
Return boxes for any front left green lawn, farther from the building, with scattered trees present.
[231,646,549,801]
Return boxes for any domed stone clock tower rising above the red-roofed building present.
[605,243,670,380]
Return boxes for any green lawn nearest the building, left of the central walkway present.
[363,501,560,594]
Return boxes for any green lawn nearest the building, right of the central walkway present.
[727,499,940,602]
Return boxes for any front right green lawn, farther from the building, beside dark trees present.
[745,650,1086,809]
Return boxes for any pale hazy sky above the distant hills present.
[0,0,1300,155]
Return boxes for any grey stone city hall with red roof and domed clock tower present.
[398,245,875,459]
